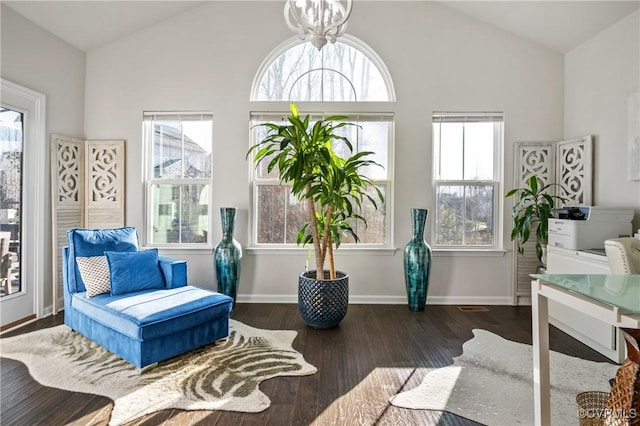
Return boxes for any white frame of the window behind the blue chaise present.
[142,111,214,250]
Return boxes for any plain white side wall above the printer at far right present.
[564,11,640,231]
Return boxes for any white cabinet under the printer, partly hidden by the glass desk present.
[546,246,625,364]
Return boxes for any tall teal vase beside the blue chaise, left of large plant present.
[214,207,242,306]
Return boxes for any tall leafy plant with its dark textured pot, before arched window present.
[247,103,384,328]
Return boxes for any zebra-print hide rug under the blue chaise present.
[0,320,317,425]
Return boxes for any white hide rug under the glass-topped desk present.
[390,329,618,426]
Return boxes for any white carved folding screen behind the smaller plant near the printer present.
[512,135,593,305]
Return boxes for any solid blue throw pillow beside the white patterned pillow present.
[104,249,165,296]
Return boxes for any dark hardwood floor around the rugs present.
[0,304,607,426]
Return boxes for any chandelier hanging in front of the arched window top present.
[284,0,353,50]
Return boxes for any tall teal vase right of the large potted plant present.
[404,209,431,311]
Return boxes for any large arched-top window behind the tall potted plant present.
[251,37,394,247]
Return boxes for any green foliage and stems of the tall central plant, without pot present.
[247,103,384,279]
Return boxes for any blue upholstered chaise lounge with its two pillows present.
[62,227,233,368]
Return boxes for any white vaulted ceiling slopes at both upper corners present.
[2,0,640,53]
